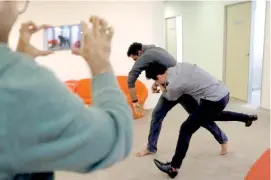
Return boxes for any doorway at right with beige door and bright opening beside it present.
[224,1,265,106]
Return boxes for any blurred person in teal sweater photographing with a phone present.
[0,1,132,180]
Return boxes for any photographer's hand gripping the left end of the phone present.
[16,21,53,58]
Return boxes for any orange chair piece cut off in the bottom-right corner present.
[245,149,270,180]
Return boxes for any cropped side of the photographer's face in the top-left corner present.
[0,1,28,43]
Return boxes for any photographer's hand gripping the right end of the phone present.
[72,16,114,75]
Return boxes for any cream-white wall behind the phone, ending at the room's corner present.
[10,1,165,108]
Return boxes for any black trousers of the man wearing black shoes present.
[171,95,249,168]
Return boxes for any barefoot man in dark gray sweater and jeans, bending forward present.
[127,43,232,157]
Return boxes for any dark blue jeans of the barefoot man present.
[148,95,228,152]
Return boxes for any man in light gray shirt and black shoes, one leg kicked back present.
[146,62,257,178]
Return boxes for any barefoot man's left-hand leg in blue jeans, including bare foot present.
[136,95,177,157]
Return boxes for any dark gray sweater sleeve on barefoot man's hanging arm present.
[128,54,151,88]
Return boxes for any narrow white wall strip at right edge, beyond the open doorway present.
[261,2,270,109]
